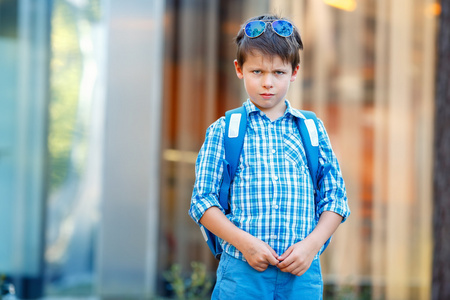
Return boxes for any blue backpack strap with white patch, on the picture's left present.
[219,106,247,213]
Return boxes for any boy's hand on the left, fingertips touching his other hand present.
[239,234,279,272]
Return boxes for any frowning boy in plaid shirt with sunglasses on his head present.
[189,15,350,300]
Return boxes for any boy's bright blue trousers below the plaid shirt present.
[211,253,323,300]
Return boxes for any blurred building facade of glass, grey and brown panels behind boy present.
[0,0,439,299]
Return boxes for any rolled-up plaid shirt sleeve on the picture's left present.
[189,117,225,223]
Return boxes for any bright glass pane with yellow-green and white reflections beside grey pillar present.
[45,0,103,295]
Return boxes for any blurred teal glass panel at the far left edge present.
[0,0,50,298]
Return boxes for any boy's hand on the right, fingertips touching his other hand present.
[278,240,318,276]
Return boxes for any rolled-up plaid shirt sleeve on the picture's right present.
[317,120,350,222]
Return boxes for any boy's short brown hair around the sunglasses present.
[234,15,303,70]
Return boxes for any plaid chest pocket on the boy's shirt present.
[283,133,307,174]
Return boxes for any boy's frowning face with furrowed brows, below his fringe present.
[234,53,299,120]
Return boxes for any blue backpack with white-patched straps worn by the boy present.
[200,106,329,259]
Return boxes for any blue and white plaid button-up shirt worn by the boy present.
[189,100,350,260]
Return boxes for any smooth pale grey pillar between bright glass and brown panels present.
[97,0,163,296]
